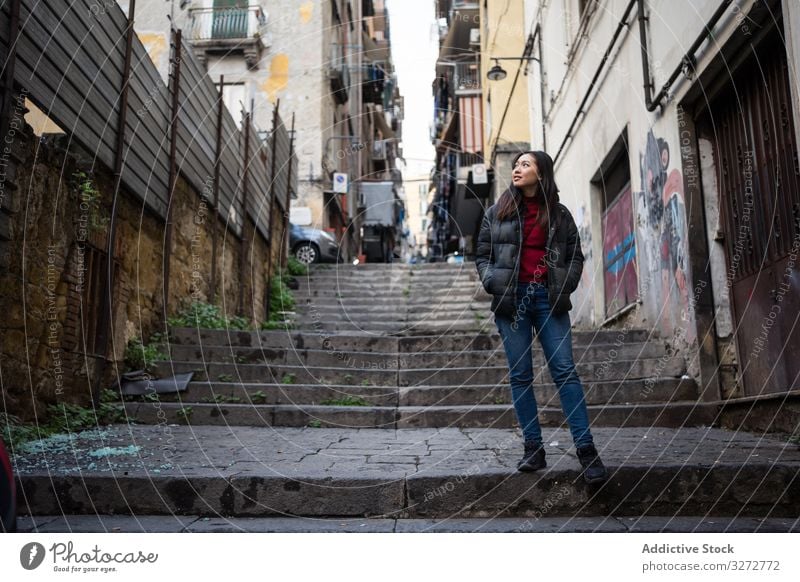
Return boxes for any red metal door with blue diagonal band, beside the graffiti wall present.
[603,183,638,317]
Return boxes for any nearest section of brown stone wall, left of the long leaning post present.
[0,126,105,417]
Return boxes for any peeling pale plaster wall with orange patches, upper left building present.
[118,0,328,227]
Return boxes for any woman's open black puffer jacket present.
[475,203,583,317]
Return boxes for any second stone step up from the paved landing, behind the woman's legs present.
[125,378,697,407]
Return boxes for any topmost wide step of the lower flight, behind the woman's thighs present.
[170,328,663,353]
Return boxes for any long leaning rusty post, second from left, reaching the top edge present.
[91,0,136,403]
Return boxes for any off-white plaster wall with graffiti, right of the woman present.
[525,0,764,388]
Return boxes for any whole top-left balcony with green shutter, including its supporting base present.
[187,4,269,69]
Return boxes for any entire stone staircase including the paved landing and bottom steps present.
[15,264,800,531]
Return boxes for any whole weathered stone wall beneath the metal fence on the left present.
[0,118,278,419]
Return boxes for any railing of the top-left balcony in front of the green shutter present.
[189,5,267,41]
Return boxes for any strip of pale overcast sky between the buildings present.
[386,0,439,179]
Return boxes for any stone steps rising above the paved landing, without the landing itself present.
[127,264,716,428]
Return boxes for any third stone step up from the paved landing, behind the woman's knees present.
[153,357,685,386]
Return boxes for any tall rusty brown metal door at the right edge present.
[705,34,800,396]
